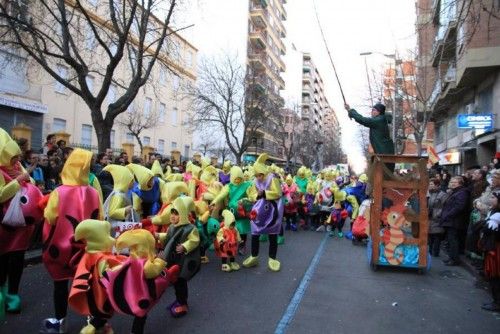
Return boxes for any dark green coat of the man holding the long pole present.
[349,109,394,154]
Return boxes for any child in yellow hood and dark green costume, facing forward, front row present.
[159,197,200,318]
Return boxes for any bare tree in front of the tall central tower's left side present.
[186,55,276,164]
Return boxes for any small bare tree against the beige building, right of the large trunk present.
[117,105,160,155]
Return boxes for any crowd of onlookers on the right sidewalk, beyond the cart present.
[428,158,500,311]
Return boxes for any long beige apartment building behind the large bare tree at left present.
[0,0,198,157]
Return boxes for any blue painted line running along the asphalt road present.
[274,233,328,334]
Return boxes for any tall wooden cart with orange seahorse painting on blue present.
[370,155,429,273]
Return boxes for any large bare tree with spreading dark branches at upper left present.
[0,0,184,151]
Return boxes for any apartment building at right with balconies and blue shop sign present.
[416,0,500,173]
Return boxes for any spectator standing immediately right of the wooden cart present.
[427,178,447,257]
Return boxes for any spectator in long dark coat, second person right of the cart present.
[440,176,469,266]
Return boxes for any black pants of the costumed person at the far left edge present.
[0,251,25,295]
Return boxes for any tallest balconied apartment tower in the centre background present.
[246,0,286,163]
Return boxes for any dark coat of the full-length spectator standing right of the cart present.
[440,187,470,229]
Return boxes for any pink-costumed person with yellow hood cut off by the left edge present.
[0,128,43,320]
